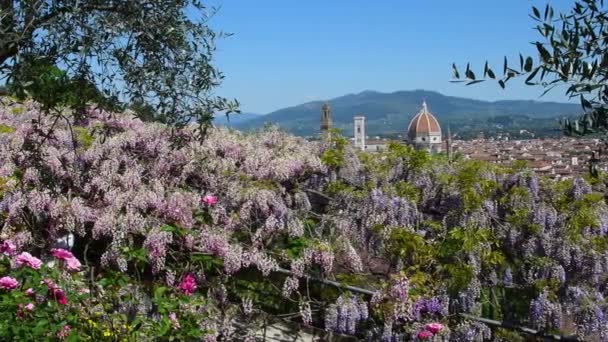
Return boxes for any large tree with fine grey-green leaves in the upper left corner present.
[0,0,238,132]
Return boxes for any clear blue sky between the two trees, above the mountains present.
[210,0,573,114]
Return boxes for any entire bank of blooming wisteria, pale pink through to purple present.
[0,102,608,341]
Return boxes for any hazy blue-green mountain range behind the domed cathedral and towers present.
[231,90,581,138]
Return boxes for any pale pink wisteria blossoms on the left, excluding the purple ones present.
[0,103,324,274]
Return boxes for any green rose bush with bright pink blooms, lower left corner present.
[0,244,230,341]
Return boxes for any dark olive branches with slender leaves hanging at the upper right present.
[453,0,608,135]
